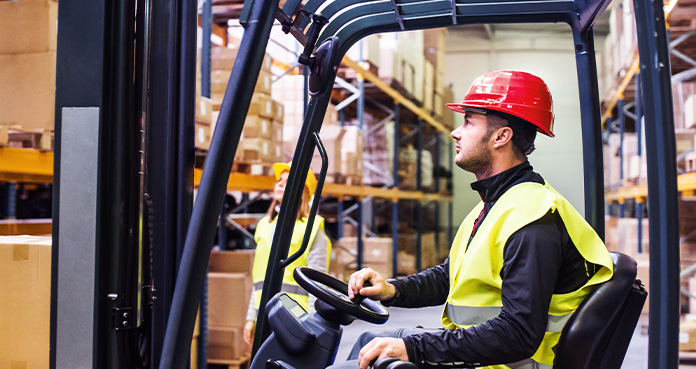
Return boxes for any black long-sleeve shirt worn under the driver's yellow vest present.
[385,162,594,368]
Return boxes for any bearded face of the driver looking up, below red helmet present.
[451,112,491,174]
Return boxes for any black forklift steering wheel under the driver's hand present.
[294,267,389,324]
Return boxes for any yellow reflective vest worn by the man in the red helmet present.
[442,182,613,369]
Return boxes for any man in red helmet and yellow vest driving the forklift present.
[330,70,613,369]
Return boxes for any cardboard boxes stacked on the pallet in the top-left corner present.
[0,0,58,137]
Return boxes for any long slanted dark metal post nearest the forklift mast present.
[160,0,279,369]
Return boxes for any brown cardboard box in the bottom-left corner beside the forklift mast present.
[0,236,51,368]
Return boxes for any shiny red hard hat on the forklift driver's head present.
[447,70,554,137]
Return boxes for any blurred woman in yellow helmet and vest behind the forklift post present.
[244,163,331,344]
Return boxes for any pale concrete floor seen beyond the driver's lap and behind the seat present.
[336,307,696,369]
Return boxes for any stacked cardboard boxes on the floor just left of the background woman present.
[208,250,254,363]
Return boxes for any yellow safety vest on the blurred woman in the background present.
[251,215,331,310]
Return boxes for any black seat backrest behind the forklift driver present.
[553,252,647,369]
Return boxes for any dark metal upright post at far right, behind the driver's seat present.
[633,0,679,369]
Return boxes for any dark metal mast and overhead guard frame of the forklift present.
[50,0,679,369]
